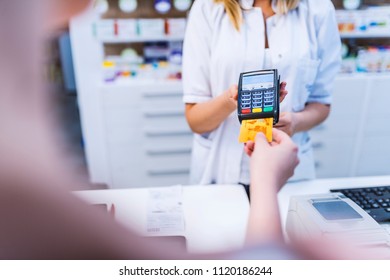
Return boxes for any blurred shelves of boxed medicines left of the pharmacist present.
[92,0,192,83]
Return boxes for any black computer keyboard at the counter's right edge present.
[330,186,390,223]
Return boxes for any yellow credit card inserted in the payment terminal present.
[238,118,274,143]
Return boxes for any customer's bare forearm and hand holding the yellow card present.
[245,129,298,244]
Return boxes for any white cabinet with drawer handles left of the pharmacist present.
[100,81,192,188]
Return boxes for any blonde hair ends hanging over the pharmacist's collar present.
[214,0,300,30]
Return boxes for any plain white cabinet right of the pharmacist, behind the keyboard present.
[310,74,390,178]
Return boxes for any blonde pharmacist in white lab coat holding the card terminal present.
[183,0,341,184]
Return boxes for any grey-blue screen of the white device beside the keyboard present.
[313,200,363,221]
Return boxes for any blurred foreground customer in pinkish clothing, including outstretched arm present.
[0,0,380,259]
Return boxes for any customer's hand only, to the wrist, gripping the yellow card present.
[245,128,299,189]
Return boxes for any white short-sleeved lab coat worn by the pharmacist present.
[183,0,341,184]
